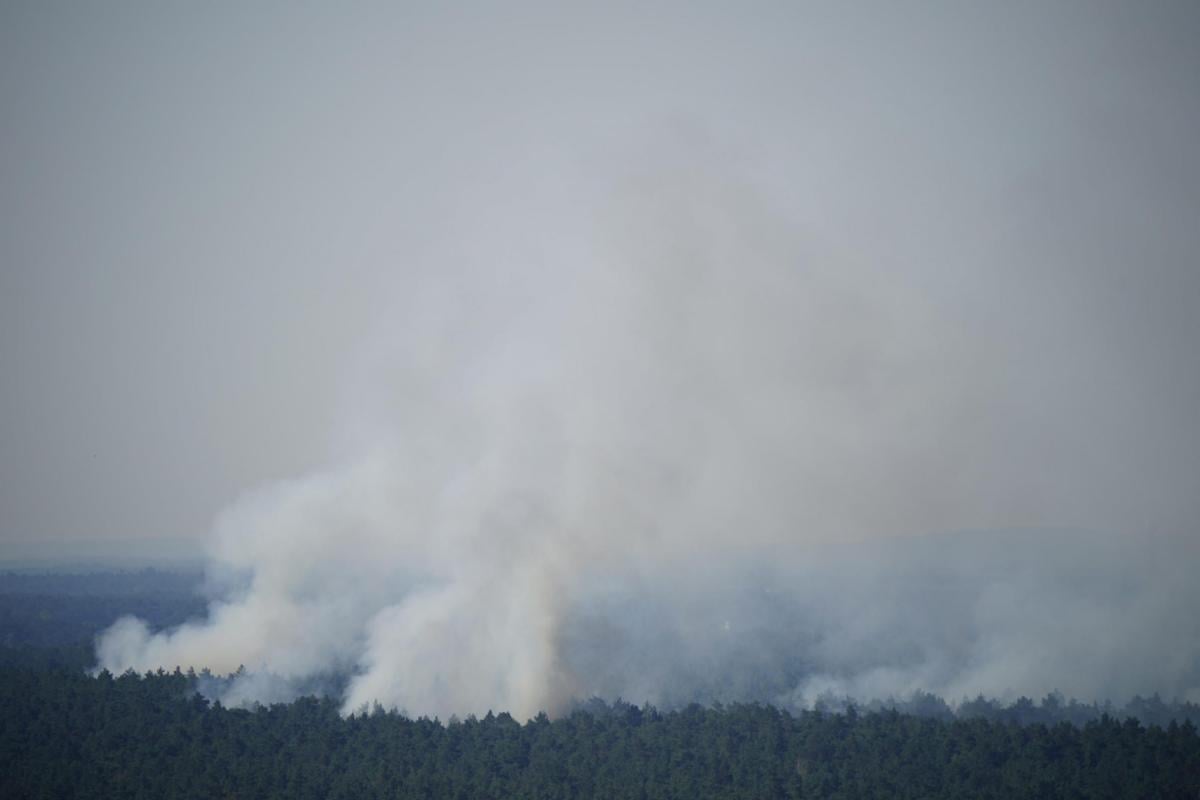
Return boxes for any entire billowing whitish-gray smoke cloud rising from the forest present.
[97,145,1200,717]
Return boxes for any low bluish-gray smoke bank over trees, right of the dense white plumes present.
[565,531,1200,708]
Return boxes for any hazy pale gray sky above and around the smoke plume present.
[0,0,1200,555]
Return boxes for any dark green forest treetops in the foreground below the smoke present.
[0,666,1200,800]
